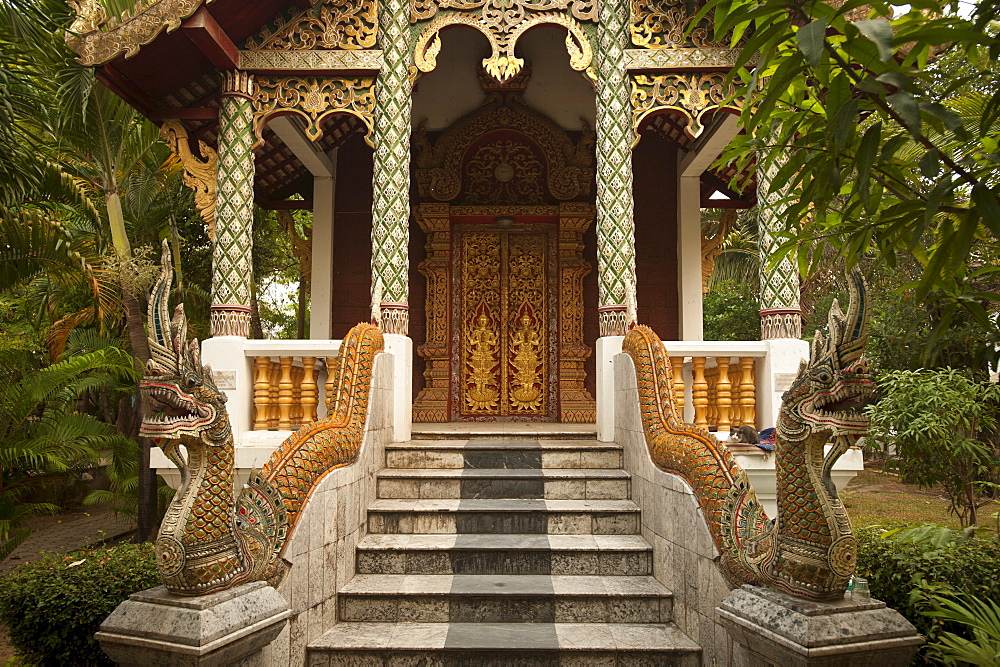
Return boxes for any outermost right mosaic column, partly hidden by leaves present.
[757,161,802,340]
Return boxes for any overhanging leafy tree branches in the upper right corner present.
[704,0,1000,350]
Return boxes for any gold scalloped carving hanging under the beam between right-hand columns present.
[631,72,742,143]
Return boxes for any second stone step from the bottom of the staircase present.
[337,574,673,623]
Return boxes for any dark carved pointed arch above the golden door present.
[414,72,596,204]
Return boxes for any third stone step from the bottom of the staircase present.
[356,534,652,576]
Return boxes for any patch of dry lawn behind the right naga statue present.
[840,468,1000,528]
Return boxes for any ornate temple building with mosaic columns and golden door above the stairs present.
[68,0,799,438]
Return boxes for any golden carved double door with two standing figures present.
[452,226,556,420]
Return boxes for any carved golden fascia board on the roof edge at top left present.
[66,0,213,66]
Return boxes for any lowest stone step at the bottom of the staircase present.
[308,623,701,667]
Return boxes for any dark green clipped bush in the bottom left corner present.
[0,544,160,665]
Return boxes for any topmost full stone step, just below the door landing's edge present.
[385,439,622,469]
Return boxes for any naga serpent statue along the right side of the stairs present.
[623,273,874,600]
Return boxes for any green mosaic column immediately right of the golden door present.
[596,0,635,336]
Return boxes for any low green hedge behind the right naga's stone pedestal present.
[856,526,1000,659]
